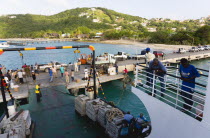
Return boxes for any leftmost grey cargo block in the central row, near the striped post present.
[75,94,90,116]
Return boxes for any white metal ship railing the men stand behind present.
[135,64,206,119]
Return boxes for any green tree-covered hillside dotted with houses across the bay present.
[0,7,210,45]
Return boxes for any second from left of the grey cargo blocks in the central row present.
[86,98,105,121]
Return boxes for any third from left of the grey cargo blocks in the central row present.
[97,104,113,128]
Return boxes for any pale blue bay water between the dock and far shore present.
[0,42,170,69]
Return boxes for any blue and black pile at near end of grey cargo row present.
[120,112,151,137]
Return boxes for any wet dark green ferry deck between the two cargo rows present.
[20,86,107,138]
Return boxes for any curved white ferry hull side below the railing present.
[132,87,210,138]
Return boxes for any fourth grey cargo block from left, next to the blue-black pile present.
[106,116,123,138]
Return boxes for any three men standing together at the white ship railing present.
[145,48,200,111]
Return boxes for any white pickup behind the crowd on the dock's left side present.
[38,62,68,72]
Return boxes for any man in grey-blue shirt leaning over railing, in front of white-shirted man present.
[147,58,167,97]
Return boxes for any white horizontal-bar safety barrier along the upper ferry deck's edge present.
[135,65,208,120]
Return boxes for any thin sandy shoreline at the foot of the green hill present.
[0,38,192,51]
